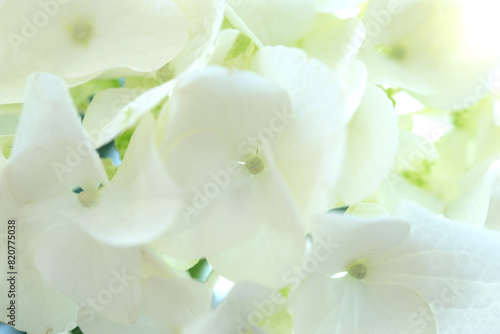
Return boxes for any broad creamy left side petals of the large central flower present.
[153,68,290,259]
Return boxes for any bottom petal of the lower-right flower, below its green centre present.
[291,274,436,334]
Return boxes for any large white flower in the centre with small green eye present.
[152,47,364,286]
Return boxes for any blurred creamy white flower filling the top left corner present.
[0,0,189,103]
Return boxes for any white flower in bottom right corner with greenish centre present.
[291,205,500,334]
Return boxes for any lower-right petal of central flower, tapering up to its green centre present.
[208,148,305,287]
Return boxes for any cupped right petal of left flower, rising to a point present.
[64,115,180,247]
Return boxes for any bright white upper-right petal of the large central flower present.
[252,47,350,213]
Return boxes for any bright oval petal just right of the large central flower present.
[336,86,399,205]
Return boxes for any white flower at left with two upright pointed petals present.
[4,74,177,324]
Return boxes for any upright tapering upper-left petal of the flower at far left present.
[7,73,107,201]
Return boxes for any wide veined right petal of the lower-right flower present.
[365,205,500,333]
